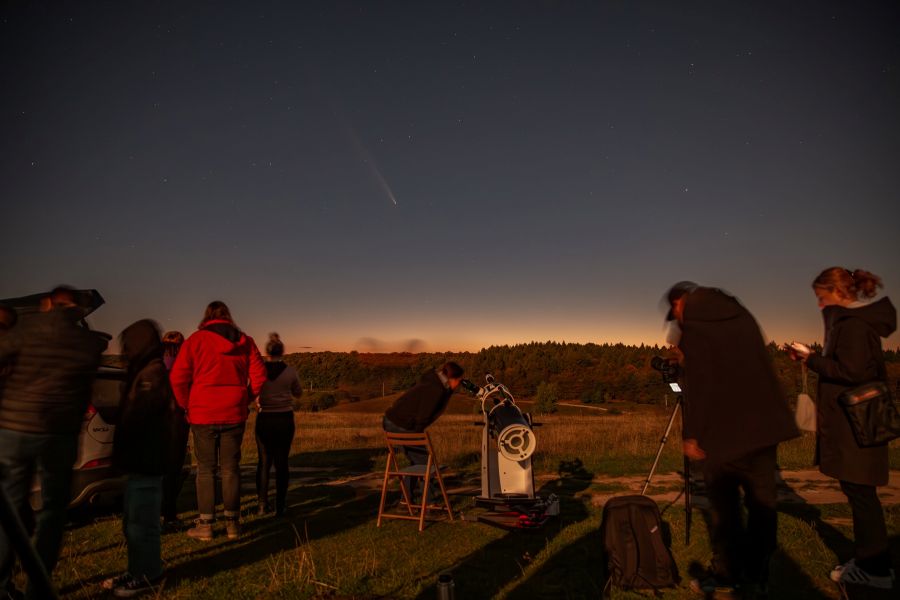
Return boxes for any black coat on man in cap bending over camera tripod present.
[679,288,799,465]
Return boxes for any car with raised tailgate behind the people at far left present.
[0,290,125,510]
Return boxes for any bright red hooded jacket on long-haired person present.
[169,320,266,425]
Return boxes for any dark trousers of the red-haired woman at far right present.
[841,481,891,575]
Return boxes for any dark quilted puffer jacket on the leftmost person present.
[0,308,107,433]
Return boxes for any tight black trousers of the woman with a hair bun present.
[256,412,294,514]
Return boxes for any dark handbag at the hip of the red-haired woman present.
[838,381,900,448]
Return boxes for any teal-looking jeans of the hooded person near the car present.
[122,474,162,581]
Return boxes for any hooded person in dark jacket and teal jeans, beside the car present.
[101,319,172,598]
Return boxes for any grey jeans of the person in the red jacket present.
[191,423,245,521]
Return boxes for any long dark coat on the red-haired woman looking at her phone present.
[806,298,897,485]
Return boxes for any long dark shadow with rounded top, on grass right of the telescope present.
[417,459,593,600]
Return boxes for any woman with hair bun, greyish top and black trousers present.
[256,333,303,517]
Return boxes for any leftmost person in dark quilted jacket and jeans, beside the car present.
[0,286,109,598]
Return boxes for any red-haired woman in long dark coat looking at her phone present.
[792,267,897,589]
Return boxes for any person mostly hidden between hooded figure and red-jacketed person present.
[162,331,190,531]
